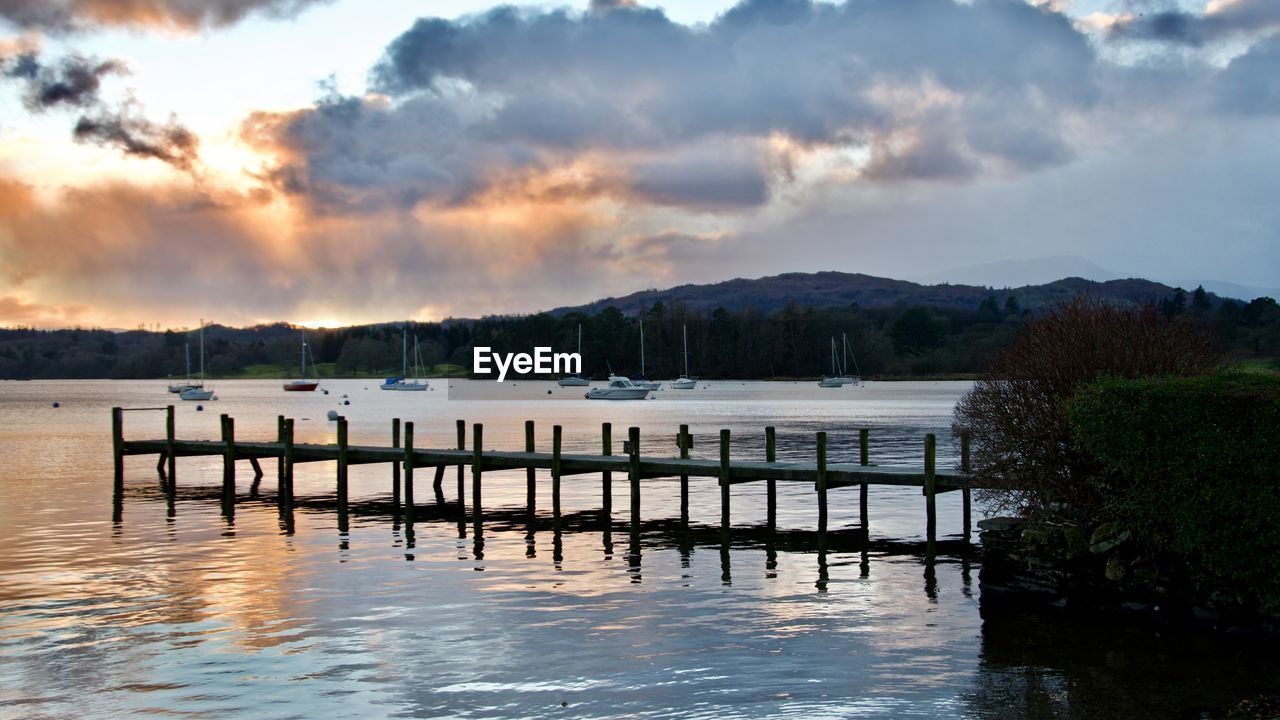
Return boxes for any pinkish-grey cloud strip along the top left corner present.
[0,0,335,32]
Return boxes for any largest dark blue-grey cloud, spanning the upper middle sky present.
[247,0,1098,210]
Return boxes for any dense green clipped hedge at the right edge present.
[1068,373,1280,612]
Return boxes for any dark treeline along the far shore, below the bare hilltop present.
[0,290,1280,379]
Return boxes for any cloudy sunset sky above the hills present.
[0,0,1280,328]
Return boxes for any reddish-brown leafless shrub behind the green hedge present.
[954,297,1217,515]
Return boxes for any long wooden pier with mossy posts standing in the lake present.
[111,405,972,540]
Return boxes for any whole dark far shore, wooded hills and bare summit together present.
[0,273,1280,379]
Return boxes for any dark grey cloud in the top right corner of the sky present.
[1107,0,1280,46]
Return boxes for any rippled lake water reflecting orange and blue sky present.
[0,380,1277,719]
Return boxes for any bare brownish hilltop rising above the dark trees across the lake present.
[552,272,1198,315]
